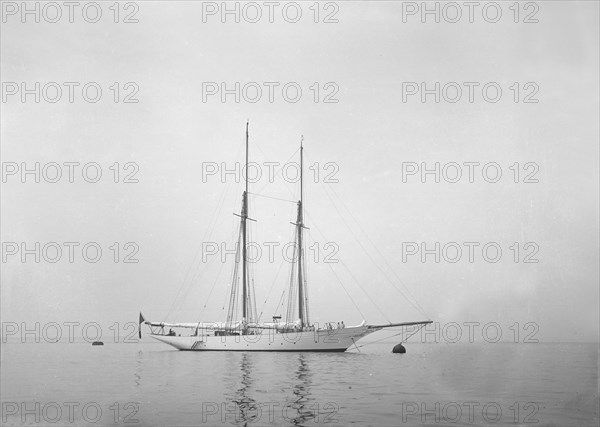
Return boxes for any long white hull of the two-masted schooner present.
[150,326,379,352]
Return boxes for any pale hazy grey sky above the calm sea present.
[1,1,599,341]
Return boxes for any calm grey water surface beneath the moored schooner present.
[1,342,599,426]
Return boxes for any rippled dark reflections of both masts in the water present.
[226,353,321,426]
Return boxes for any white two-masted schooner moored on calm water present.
[139,123,431,352]
